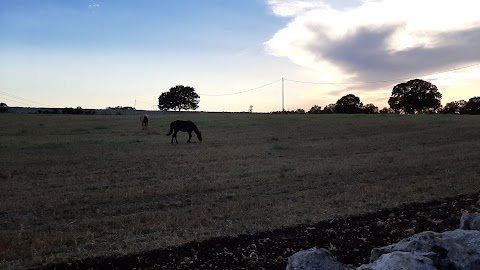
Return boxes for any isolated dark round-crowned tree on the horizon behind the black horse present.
[158,85,200,111]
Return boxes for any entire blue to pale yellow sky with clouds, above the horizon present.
[0,0,480,112]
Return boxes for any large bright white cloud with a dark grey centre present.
[265,0,480,86]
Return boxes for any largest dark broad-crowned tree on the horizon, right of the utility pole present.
[388,79,442,113]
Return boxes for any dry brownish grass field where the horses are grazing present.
[0,113,480,269]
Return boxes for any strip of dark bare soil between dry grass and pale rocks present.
[32,193,480,270]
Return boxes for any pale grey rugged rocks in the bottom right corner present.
[287,213,480,270]
